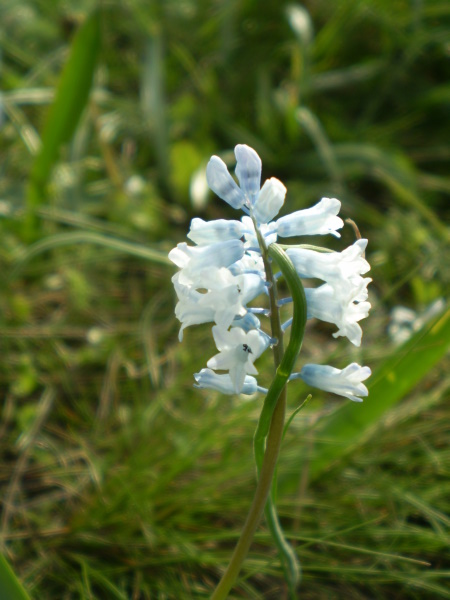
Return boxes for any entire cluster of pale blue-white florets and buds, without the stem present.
[169,145,371,401]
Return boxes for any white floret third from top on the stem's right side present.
[305,278,371,346]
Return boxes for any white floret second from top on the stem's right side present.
[286,239,370,287]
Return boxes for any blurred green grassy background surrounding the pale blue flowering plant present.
[0,0,450,600]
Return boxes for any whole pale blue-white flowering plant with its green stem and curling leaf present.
[169,145,371,600]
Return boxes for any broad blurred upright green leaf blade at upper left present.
[27,10,100,212]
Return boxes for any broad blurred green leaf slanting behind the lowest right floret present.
[309,309,450,478]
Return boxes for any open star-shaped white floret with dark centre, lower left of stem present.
[206,326,269,394]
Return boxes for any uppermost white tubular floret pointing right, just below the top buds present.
[277,198,344,237]
